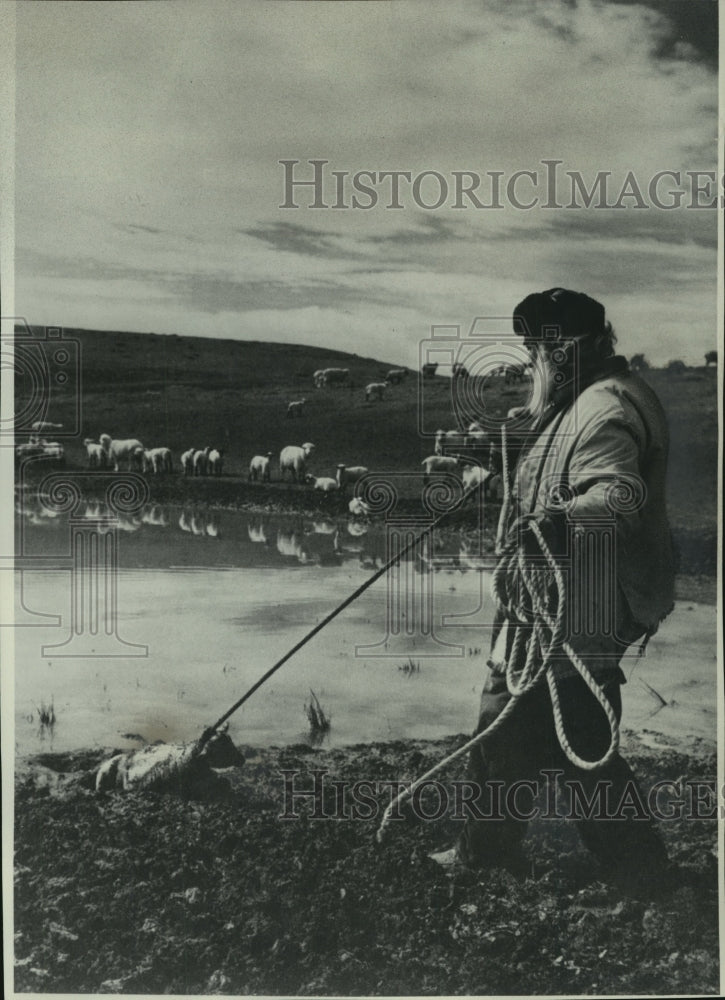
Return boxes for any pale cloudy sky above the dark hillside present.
[9,0,719,366]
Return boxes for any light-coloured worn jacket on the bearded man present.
[504,359,674,642]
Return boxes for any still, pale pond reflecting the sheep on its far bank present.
[14,502,715,754]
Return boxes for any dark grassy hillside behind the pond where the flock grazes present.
[16,330,718,559]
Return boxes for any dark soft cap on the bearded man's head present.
[514,288,604,341]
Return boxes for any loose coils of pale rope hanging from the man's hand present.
[376,425,619,843]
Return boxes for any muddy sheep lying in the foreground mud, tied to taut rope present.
[96,723,244,798]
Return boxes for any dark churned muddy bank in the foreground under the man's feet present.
[15,732,718,995]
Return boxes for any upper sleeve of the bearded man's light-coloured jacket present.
[568,397,647,534]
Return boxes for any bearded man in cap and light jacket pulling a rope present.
[434,288,674,892]
